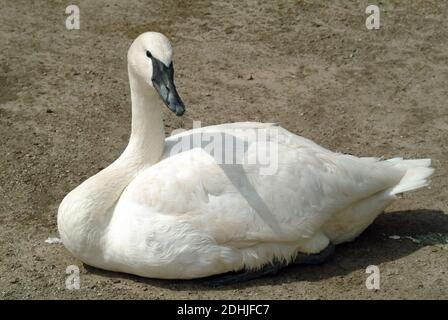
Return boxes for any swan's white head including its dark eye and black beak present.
[128,32,185,116]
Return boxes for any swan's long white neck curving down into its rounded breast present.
[58,65,165,265]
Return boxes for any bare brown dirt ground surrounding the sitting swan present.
[0,0,448,299]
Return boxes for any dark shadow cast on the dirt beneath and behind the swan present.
[84,209,448,291]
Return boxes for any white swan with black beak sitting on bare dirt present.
[58,32,433,279]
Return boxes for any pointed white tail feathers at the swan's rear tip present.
[387,158,434,195]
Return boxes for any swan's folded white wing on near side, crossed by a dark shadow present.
[121,145,401,246]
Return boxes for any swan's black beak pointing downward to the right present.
[151,57,185,116]
